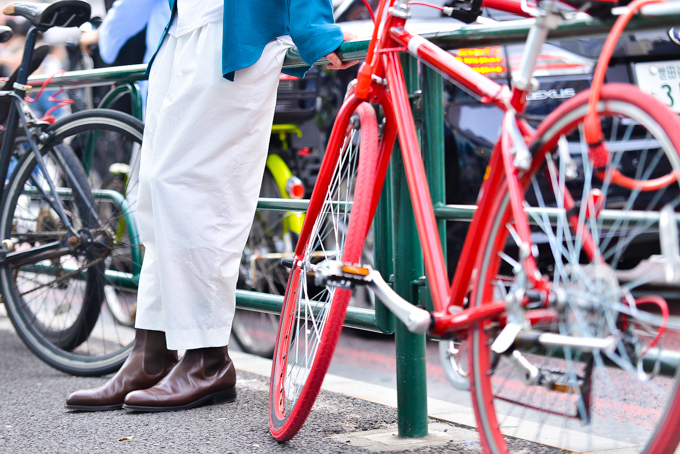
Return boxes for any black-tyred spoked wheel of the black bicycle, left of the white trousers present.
[0,109,143,376]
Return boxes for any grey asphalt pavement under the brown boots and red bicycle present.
[0,316,559,454]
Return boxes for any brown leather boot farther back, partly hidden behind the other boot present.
[66,329,177,411]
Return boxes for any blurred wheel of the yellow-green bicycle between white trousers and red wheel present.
[231,168,290,359]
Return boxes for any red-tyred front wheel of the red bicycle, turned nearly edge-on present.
[269,103,378,441]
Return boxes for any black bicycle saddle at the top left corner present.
[2,0,91,29]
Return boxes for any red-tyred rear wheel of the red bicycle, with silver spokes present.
[469,85,680,453]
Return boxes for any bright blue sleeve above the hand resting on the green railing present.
[289,0,343,66]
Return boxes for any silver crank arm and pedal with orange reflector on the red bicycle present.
[314,262,432,334]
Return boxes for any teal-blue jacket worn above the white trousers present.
[147,0,343,80]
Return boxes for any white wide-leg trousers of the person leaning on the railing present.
[136,22,292,350]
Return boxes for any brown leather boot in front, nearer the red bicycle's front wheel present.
[123,347,236,411]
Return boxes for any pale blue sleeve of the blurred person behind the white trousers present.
[99,0,156,64]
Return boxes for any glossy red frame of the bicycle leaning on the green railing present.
[322,0,564,336]
